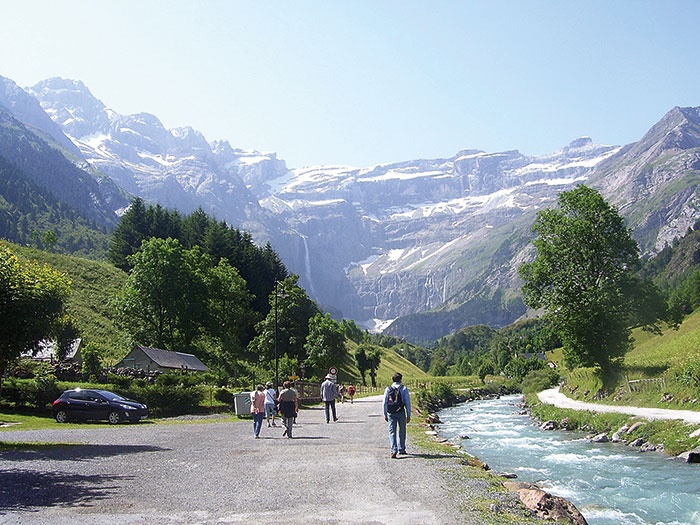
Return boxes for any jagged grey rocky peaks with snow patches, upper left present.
[27,78,286,234]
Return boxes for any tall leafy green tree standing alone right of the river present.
[519,186,651,371]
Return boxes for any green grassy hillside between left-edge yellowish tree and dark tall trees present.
[3,242,128,364]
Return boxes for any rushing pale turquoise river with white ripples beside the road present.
[439,396,700,525]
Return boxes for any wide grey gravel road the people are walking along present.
[0,396,515,525]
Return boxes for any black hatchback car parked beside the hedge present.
[53,388,148,425]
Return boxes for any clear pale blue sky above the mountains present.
[0,0,700,168]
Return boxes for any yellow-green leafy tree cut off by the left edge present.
[0,245,71,377]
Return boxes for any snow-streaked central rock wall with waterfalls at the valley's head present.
[260,138,619,332]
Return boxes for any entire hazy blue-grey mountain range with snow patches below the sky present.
[0,77,700,342]
